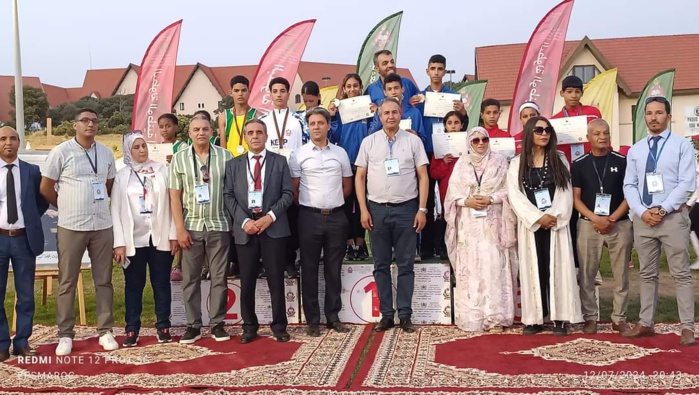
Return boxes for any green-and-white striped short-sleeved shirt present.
[170,145,233,232]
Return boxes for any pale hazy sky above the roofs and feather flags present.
[0,0,699,87]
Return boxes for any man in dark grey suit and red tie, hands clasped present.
[223,119,293,344]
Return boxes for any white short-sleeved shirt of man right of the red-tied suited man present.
[289,142,352,209]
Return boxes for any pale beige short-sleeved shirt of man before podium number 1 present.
[354,130,429,203]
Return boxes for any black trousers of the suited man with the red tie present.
[236,233,288,333]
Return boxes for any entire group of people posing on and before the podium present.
[0,50,696,361]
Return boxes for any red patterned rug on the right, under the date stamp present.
[351,324,699,394]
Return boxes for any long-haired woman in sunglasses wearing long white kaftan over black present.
[507,117,583,336]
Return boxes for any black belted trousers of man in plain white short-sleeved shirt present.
[299,207,348,324]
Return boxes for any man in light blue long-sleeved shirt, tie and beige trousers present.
[622,97,696,346]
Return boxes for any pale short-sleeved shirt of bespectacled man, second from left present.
[43,138,116,232]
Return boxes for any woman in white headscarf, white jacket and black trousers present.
[111,131,178,347]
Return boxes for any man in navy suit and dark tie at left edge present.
[0,126,48,362]
